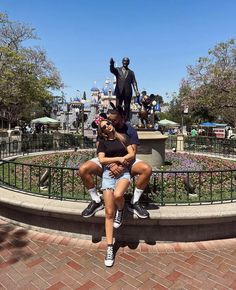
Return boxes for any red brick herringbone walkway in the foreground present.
[0,220,236,290]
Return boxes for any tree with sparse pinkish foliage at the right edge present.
[179,39,236,127]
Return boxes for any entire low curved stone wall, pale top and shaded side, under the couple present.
[0,187,236,244]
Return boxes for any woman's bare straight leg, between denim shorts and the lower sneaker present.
[103,189,115,245]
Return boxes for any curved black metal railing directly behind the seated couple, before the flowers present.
[0,160,236,205]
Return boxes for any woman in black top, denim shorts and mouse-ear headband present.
[97,120,135,267]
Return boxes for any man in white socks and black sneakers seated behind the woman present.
[79,109,152,218]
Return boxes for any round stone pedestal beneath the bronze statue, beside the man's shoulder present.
[136,130,168,170]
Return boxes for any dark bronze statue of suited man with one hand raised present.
[110,57,140,121]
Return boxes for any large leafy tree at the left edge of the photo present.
[0,14,63,127]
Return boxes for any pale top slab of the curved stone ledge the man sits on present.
[0,187,236,226]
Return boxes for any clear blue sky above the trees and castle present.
[0,0,236,101]
